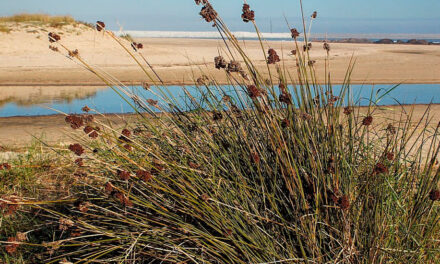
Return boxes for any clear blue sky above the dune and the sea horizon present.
[0,0,440,34]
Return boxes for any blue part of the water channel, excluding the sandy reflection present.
[0,84,440,117]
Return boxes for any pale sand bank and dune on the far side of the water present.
[0,23,440,85]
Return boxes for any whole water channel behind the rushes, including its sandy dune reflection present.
[0,84,440,117]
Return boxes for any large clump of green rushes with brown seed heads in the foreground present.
[18,1,440,264]
